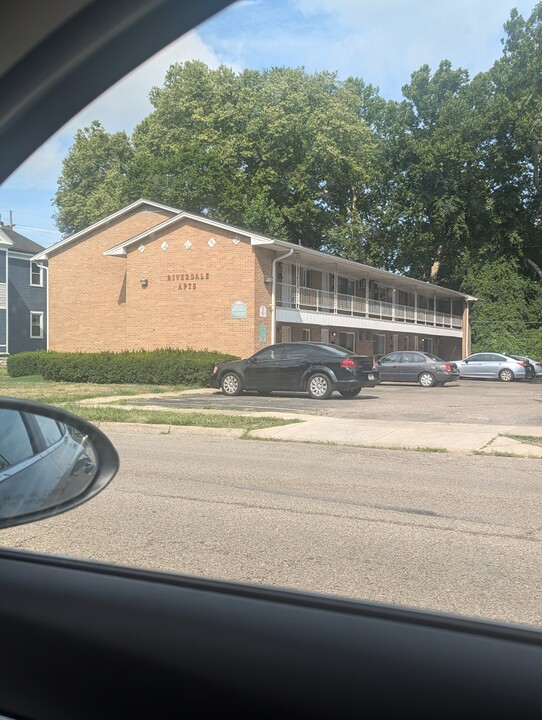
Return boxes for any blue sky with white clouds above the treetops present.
[0,0,536,247]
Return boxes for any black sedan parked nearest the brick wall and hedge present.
[211,342,379,400]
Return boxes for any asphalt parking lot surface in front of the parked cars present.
[141,380,542,427]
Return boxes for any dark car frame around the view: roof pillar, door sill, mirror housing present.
[0,0,542,720]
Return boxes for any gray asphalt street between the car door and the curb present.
[3,430,542,627]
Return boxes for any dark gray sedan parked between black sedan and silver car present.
[376,351,459,387]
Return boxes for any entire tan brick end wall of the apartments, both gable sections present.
[49,212,274,357]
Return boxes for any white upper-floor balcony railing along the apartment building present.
[276,283,462,329]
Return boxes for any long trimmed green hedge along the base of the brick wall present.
[7,348,238,387]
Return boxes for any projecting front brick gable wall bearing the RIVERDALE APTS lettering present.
[124,219,271,357]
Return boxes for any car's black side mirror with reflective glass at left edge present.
[0,397,119,528]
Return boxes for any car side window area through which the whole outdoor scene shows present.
[0,0,542,636]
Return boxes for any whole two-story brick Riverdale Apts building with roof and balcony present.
[32,200,474,359]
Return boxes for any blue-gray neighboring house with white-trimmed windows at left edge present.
[0,222,47,355]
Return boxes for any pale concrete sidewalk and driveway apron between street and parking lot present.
[86,390,542,458]
